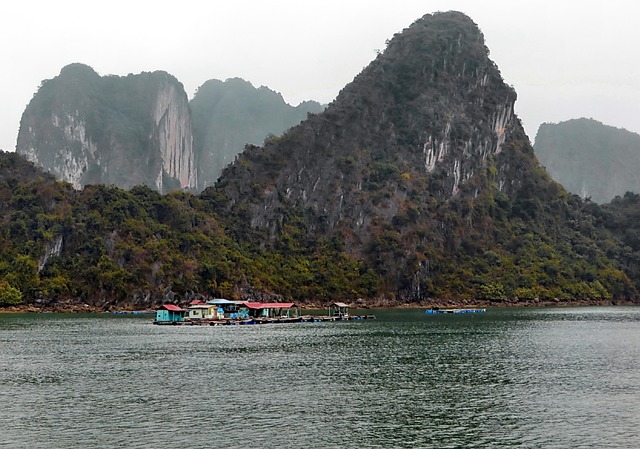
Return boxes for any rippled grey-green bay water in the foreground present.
[0,307,640,449]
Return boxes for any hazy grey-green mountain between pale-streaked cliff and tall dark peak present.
[190,78,323,190]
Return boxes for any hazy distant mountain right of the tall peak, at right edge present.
[534,118,640,203]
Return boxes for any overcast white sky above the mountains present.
[0,0,640,151]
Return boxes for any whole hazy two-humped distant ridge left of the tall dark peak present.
[16,64,322,192]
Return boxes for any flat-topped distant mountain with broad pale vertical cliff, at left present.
[16,64,197,192]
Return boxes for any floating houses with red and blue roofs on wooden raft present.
[153,298,375,326]
